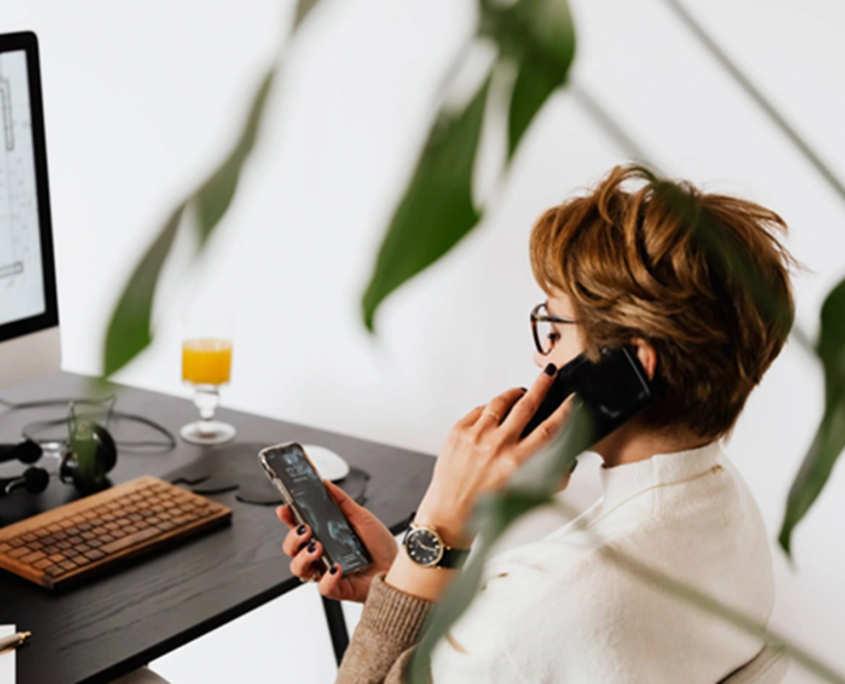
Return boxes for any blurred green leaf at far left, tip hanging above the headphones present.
[103,204,185,377]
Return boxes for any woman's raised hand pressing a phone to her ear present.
[414,364,572,548]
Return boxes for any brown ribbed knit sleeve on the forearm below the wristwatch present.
[336,574,434,684]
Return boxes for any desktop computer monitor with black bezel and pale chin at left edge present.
[0,33,61,387]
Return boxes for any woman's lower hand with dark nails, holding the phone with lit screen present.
[276,480,399,603]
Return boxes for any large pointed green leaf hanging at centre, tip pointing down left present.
[362,77,490,331]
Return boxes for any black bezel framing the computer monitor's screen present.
[0,31,59,342]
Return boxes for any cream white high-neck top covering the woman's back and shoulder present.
[432,442,774,684]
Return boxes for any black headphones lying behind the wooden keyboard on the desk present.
[0,418,117,498]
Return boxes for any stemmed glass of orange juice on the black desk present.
[179,319,236,444]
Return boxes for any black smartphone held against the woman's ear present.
[522,347,656,444]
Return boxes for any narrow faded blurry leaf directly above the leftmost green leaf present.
[193,66,276,246]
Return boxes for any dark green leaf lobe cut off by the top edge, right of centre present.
[479,0,575,159]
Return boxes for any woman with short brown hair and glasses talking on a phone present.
[278,167,793,684]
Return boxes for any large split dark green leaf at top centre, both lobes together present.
[362,0,575,330]
